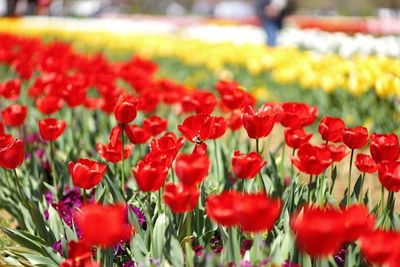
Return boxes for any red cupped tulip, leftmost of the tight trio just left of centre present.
[132,160,168,192]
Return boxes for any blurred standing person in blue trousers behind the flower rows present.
[256,0,295,46]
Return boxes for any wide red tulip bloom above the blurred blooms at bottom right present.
[292,144,333,175]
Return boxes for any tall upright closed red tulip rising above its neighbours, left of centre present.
[114,95,137,124]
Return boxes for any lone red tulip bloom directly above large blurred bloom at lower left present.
[68,158,107,190]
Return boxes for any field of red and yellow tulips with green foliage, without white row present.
[0,16,400,267]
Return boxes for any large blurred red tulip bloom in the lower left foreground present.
[75,204,133,248]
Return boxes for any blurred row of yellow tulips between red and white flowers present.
[0,18,400,98]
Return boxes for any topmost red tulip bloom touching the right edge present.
[369,134,400,163]
